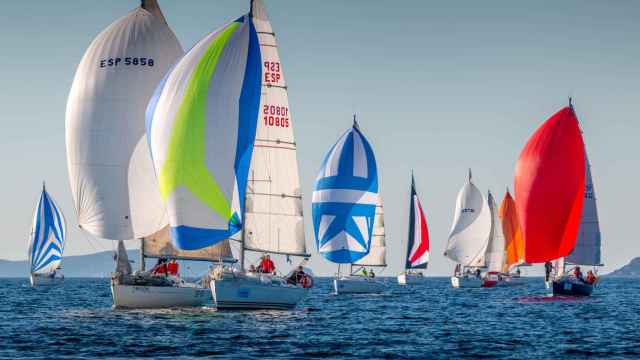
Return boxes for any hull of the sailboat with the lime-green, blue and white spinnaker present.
[211,275,309,310]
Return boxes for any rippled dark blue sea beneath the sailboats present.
[0,278,640,359]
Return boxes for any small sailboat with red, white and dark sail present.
[398,174,429,285]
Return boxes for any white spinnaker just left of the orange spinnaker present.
[445,180,491,266]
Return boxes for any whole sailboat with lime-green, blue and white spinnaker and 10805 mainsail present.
[147,0,311,309]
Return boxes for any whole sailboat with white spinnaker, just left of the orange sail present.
[444,170,492,288]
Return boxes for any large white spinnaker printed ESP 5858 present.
[65,8,183,240]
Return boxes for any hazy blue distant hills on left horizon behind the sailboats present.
[0,250,209,278]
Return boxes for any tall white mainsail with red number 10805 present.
[244,0,306,255]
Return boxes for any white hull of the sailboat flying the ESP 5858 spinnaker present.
[111,281,210,309]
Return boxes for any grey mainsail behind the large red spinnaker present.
[566,153,602,265]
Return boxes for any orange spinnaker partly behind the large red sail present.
[499,190,524,272]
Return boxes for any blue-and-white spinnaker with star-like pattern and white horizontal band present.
[312,116,378,264]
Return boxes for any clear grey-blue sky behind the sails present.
[0,0,640,275]
